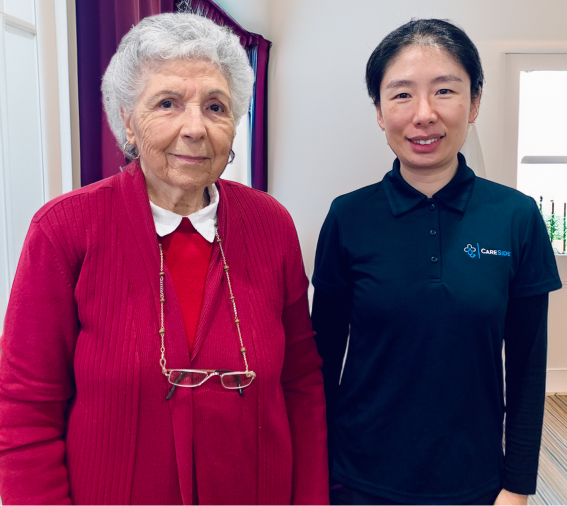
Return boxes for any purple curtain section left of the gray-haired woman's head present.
[76,0,174,186]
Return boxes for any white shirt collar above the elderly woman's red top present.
[150,184,219,242]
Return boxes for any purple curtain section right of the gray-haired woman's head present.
[175,0,272,191]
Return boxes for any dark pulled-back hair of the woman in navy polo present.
[366,19,484,105]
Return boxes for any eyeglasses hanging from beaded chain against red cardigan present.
[166,369,256,400]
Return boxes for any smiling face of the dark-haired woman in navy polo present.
[376,46,480,174]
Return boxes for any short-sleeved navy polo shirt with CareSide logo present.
[313,154,561,504]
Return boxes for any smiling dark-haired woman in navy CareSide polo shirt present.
[313,19,561,504]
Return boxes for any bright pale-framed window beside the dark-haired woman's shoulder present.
[506,54,567,255]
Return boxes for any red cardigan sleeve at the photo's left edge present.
[0,216,78,504]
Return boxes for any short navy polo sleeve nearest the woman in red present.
[313,201,352,293]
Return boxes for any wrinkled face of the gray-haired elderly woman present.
[123,60,235,192]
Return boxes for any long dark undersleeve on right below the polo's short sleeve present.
[502,293,549,495]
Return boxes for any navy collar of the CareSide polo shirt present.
[382,153,476,216]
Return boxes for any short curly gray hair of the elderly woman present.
[102,13,254,154]
